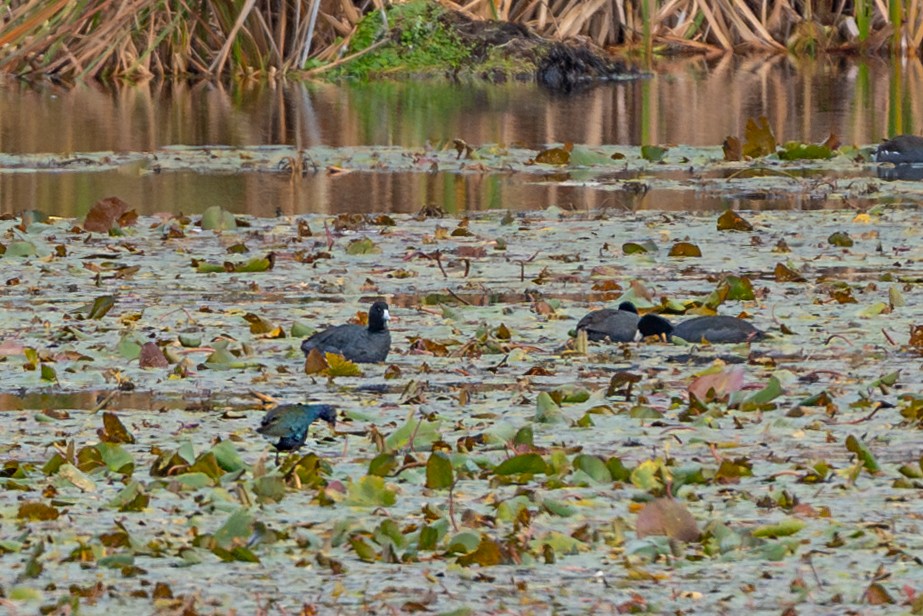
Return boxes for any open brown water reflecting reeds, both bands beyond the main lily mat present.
[0,56,923,216]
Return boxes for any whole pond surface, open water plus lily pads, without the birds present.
[0,53,923,616]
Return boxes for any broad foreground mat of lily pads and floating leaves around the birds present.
[0,205,923,614]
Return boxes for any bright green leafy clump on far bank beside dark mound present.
[335,0,471,80]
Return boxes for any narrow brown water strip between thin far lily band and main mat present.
[0,171,868,217]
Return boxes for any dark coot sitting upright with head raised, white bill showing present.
[301,301,391,364]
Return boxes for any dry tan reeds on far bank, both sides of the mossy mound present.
[0,0,923,79]
